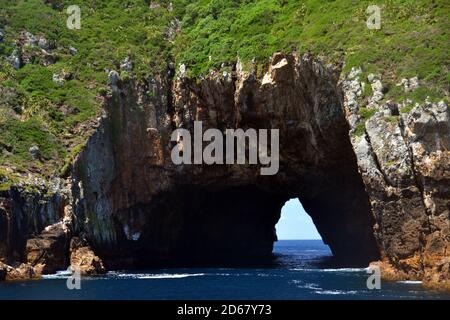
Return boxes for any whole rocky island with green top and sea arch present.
[0,0,450,290]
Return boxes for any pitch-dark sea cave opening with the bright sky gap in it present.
[125,183,377,266]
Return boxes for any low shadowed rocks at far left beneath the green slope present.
[0,179,71,279]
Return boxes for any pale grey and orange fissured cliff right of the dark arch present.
[343,70,450,289]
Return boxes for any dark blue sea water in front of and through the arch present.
[0,240,450,300]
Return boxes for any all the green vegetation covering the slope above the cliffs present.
[0,0,450,180]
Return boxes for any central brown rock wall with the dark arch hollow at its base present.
[73,54,379,267]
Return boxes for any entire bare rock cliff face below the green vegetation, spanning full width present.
[0,54,450,287]
